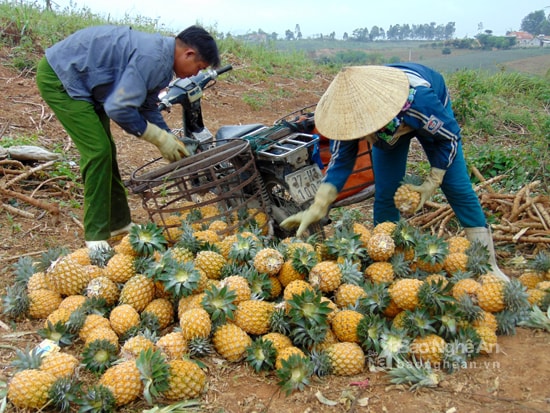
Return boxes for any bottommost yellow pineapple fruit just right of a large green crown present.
[162,360,207,400]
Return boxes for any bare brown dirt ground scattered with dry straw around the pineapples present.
[0,51,550,413]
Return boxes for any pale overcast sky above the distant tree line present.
[52,0,550,39]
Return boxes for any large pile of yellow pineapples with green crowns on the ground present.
[2,204,550,412]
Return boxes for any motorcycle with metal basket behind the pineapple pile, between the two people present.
[129,65,374,238]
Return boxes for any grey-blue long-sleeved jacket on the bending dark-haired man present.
[46,26,175,136]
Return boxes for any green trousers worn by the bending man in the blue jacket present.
[36,57,131,241]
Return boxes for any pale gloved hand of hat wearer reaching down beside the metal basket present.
[281,183,338,237]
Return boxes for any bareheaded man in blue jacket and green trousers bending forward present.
[36,26,220,248]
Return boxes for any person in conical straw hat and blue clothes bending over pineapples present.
[281,63,508,280]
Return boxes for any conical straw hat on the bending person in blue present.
[315,66,409,141]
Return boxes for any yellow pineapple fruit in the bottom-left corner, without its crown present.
[7,369,56,409]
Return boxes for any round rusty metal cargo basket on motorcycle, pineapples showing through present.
[127,139,271,243]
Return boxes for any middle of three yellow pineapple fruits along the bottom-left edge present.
[99,359,143,406]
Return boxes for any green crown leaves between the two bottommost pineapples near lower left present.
[136,348,170,405]
